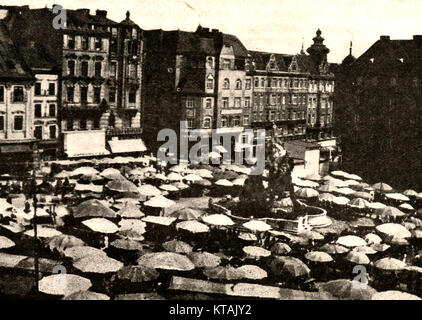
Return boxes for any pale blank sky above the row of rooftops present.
[2,0,422,63]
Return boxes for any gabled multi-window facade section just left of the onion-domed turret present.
[248,51,308,140]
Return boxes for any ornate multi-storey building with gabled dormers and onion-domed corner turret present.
[247,30,334,141]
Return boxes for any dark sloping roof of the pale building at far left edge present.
[0,21,33,79]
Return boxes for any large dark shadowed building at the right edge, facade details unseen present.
[335,35,422,189]
